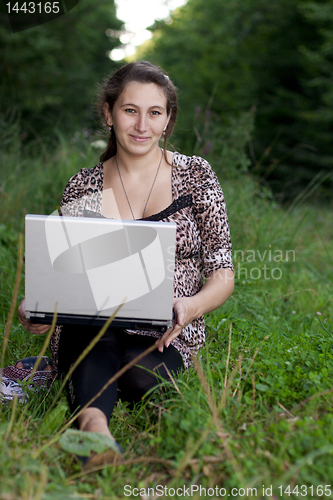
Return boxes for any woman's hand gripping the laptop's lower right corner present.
[157,297,200,352]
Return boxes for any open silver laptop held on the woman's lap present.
[25,215,176,332]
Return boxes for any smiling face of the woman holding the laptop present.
[104,82,169,156]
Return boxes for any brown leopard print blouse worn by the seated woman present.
[51,153,233,367]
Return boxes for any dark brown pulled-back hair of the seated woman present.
[96,61,177,161]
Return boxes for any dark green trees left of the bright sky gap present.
[0,0,122,140]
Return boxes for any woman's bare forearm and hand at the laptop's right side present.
[158,269,234,352]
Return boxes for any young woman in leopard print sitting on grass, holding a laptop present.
[19,61,234,466]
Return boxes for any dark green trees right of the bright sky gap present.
[138,0,333,198]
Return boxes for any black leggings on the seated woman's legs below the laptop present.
[59,325,184,421]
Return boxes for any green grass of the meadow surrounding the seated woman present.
[0,134,333,500]
